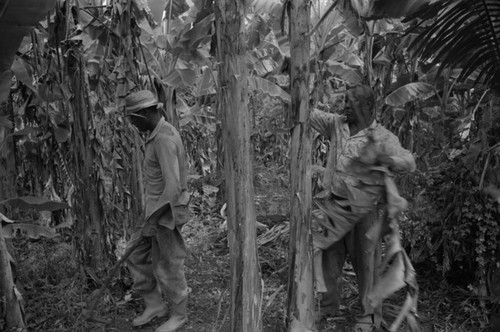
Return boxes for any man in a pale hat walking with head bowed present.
[125,90,189,332]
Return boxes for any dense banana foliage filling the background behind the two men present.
[0,0,500,325]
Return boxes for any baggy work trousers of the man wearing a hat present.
[127,227,188,304]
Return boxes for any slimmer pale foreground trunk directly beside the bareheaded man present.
[288,0,314,332]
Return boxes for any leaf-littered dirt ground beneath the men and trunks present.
[6,176,500,332]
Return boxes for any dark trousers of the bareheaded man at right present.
[320,210,382,321]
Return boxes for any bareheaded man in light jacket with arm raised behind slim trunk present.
[311,85,415,332]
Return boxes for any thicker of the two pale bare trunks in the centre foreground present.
[215,0,262,332]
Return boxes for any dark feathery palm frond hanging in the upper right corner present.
[408,0,500,89]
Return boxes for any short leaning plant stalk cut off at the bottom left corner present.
[0,224,26,331]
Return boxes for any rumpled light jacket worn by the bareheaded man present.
[311,109,415,212]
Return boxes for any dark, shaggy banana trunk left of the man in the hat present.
[68,49,109,272]
